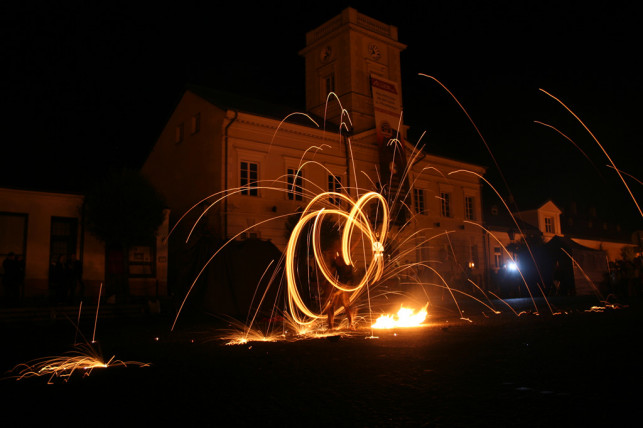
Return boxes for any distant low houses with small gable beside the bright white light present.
[485,200,635,294]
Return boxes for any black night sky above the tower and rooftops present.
[0,0,643,227]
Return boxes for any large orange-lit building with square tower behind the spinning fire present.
[142,8,485,300]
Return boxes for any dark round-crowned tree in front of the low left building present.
[83,170,165,301]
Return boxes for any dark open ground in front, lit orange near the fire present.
[0,298,643,427]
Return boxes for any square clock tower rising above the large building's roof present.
[299,7,406,133]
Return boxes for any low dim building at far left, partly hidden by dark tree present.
[0,188,168,302]
